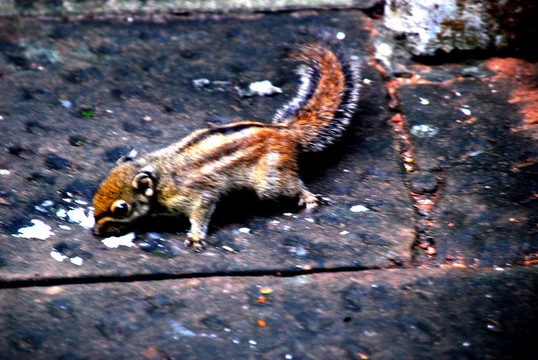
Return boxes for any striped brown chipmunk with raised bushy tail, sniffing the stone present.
[93,43,359,252]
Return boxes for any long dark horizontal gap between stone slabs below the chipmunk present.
[0,266,376,290]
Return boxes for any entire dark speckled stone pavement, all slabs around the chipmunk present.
[0,11,538,359]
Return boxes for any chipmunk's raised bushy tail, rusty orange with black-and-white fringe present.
[273,43,360,152]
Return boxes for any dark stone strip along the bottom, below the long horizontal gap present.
[0,267,538,360]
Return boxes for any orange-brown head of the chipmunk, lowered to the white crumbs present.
[93,157,155,236]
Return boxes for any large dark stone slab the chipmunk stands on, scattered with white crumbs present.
[0,11,414,280]
